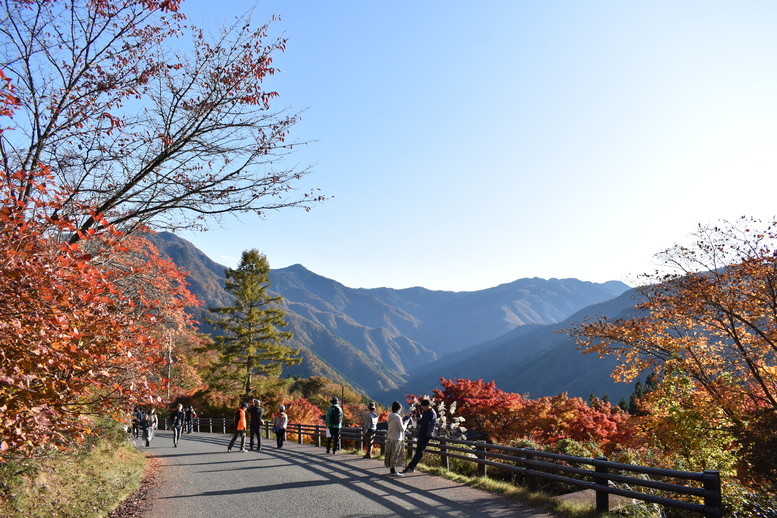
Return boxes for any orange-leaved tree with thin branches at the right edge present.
[571,218,777,492]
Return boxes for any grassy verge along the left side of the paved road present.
[0,422,146,518]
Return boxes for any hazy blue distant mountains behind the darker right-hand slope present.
[147,232,630,398]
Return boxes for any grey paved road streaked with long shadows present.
[139,431,552,518]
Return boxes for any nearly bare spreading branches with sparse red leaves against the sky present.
[0,0,322,242]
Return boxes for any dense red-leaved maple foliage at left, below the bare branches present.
[0,67,200,457]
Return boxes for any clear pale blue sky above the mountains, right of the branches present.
[180,0,777,291]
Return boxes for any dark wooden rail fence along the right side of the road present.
[163,417,723,518]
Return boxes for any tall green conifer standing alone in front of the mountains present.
[206,249,302,394]
